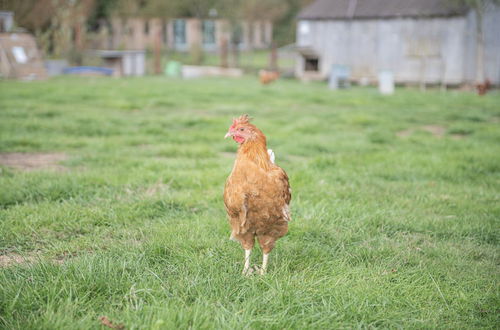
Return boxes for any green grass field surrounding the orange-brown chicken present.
[0,77,500,329]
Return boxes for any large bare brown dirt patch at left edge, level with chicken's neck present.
[0,152,68,172]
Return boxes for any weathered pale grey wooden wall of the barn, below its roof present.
[296,11,500,84]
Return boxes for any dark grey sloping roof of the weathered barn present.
[298,0,467,19]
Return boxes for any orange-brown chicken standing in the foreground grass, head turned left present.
[224,115,292,275]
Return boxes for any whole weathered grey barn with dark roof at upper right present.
[295,0,500,85]
